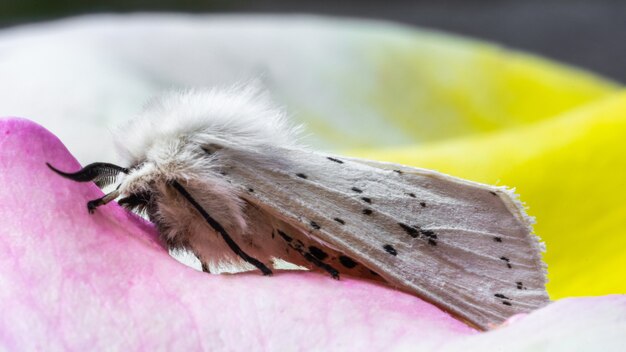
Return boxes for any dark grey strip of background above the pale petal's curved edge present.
[0,0,626,82]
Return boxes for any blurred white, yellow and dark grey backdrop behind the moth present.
[0,0,626,298]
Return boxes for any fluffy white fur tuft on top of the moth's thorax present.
[116,84,298,166]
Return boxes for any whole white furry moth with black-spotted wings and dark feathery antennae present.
[48,86,549,329]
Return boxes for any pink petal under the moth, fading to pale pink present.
[0,119,475,351]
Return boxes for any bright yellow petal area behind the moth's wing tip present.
[353,93,626,299]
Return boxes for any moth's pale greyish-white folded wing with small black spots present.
[228,150,549,329]
